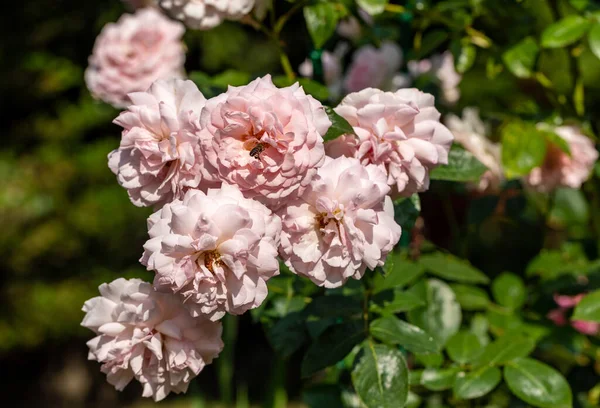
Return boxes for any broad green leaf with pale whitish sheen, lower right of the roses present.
[408,279,462,346]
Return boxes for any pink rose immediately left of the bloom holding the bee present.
[108,79,214,206]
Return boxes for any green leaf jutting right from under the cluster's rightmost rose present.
[429,145,487,182]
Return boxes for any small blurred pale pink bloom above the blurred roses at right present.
[406,51,462,105]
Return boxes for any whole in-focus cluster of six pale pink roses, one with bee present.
[83,72,452,400]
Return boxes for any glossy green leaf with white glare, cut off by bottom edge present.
[352,342,408,408]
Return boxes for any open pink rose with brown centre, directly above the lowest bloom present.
[140,184,281,320]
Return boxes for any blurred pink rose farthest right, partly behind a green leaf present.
[525,126,598,193]
